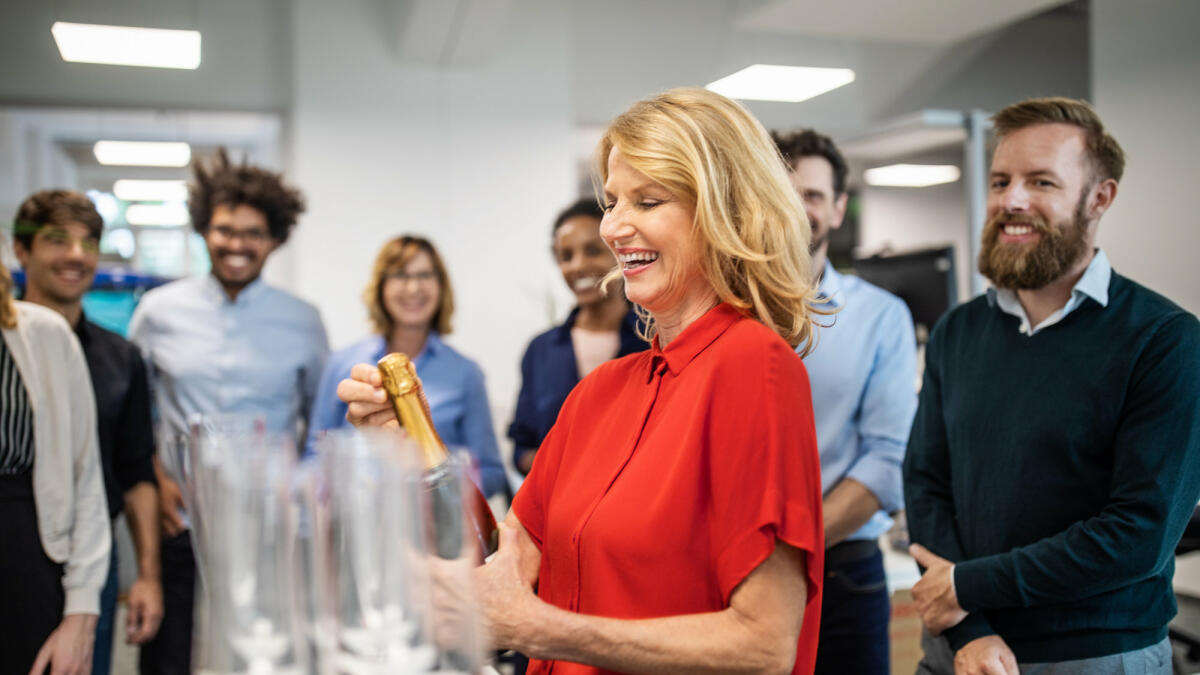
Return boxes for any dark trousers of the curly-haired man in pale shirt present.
[138,532,196,675]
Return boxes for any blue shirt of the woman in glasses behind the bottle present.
[307,333,508,497]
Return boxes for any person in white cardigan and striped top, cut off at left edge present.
[0,254,110,673]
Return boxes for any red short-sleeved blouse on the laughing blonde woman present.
[512,304,824,674]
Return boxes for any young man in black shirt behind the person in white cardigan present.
[13,190,162,675]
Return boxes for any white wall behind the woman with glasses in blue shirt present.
[280,0,575,448]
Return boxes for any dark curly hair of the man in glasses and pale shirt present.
[187,148,305,244]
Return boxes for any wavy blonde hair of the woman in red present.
[596,88,829,356]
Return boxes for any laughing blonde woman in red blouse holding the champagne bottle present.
[340,89,824,674]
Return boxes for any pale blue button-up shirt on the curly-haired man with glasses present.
[130,275,329,478]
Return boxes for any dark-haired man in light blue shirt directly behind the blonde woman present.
[774,130,917,675]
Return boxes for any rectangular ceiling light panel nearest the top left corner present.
[50,22,200,71]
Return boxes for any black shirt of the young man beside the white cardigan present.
[76,317,157,518]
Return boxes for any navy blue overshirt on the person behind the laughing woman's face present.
[509,307,649,473]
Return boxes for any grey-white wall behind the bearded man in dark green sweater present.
[1092,0,1200,313]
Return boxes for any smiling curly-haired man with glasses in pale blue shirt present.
[130,149,329,674]
